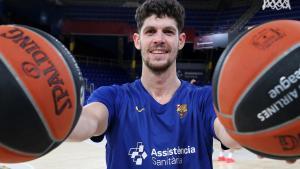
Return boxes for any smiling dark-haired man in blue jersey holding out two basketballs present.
[69,0,296,169]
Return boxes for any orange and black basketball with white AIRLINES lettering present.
[213,20,300,159]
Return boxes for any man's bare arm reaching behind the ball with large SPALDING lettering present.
[68,102,108,141]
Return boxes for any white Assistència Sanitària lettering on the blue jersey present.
[151,146,196,166]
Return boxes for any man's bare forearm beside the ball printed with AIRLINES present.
[214,118,241,149]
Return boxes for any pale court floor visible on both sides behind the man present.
[0,141,300,169]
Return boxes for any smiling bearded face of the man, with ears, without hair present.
[133,15,186,73]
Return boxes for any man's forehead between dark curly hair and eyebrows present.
[142,15,178,30]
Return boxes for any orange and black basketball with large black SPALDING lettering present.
[0,25,83,163]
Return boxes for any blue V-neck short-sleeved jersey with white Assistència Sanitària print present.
[88,80,216,169]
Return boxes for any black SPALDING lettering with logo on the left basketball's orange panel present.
[0,28,72,115]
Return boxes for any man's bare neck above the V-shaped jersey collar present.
[141,65,181,104]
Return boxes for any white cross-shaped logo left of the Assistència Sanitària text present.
[128,142,147,165]
